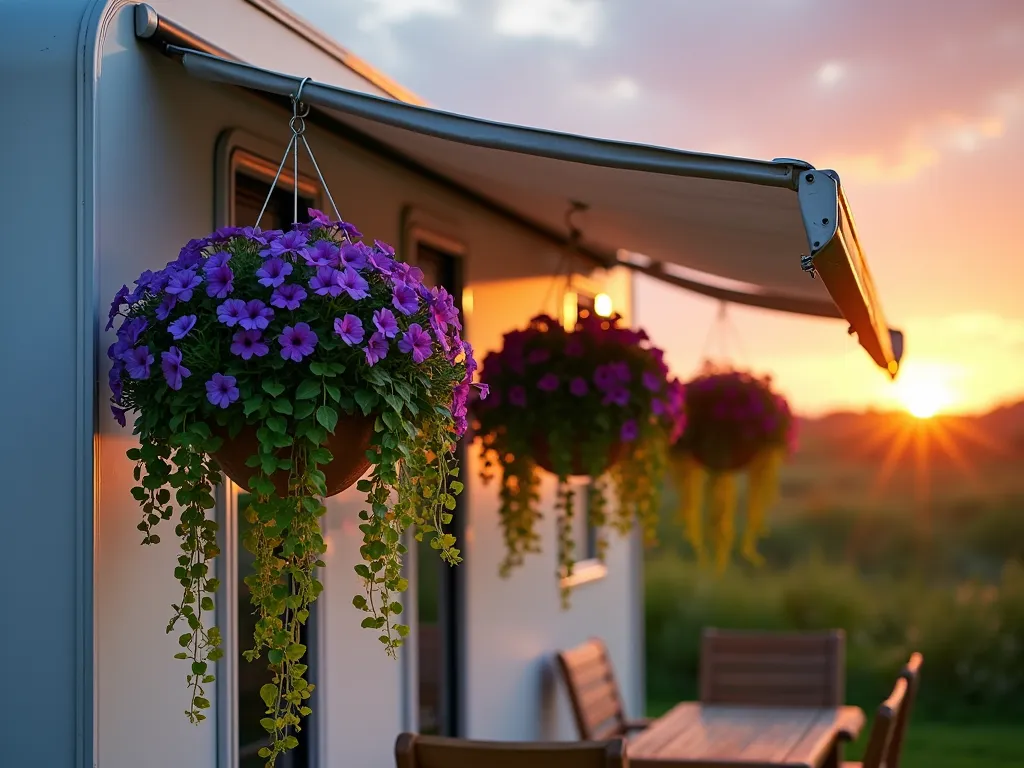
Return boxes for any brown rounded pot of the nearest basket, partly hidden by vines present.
[213,414,376,497]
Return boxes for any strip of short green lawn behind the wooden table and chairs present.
[647,700,1024,768]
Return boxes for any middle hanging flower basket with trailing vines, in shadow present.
[474,313,684,605]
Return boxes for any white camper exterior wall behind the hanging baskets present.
[0,0,642,768]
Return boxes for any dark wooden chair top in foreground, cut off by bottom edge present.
[394,733,629,768]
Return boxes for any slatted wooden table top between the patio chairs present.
[627,701,864,768]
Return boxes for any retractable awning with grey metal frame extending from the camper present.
[136,8,902,376]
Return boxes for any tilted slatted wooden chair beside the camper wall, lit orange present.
[558,638,650,741]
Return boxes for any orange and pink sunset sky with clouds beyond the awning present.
[287,0,1024,414]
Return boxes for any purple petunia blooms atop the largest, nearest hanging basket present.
[106,209,477,435]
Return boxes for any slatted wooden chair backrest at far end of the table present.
[700,629,846,707]
